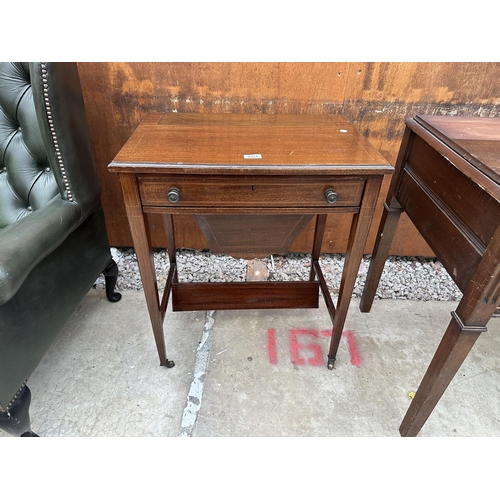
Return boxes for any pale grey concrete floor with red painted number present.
[0,290,500,437]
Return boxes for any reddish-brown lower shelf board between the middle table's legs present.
[172,281,319,311]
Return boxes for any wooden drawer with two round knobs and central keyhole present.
[139,176,365,207]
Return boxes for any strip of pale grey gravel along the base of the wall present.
[94,248,462,301]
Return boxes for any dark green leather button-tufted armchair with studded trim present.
[0,62,121,436]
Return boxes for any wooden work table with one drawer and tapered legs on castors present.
[109,113,394,369]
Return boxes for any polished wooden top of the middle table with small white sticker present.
[109,113,393,175]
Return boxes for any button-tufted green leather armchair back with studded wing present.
[0,62,99,229]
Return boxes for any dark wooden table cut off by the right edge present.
[360,116,500,436]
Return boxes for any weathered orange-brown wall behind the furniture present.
[78,62,500,255]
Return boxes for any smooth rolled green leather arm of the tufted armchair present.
[0,197,81,305]
